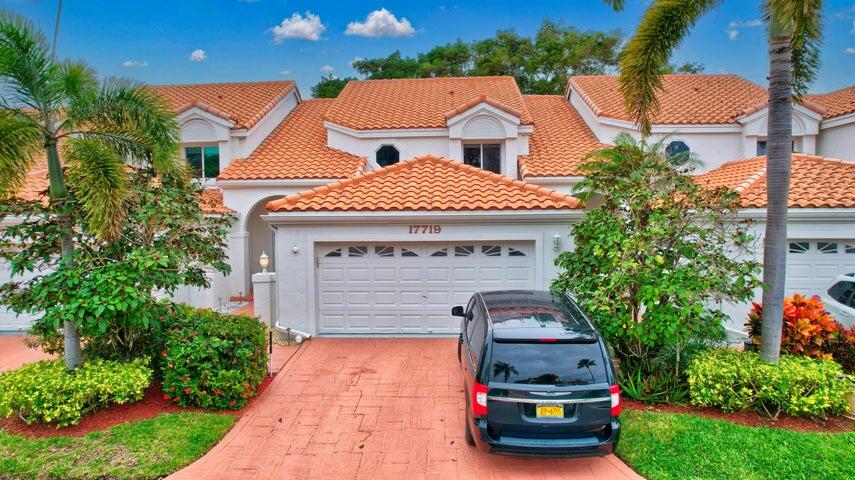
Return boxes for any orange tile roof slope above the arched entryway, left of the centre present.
[217,99,365,180]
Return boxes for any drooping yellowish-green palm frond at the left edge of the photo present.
[0,110,43,199]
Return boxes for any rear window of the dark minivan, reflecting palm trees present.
[489,342,608,387]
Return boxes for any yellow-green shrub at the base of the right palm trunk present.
[688,349,852,418]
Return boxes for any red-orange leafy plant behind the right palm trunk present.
[746,293,843,359]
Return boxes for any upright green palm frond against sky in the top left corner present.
[0,10,61,110]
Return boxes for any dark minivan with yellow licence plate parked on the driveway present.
[452,290,621,456]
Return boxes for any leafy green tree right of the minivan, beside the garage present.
[552,134,759,374]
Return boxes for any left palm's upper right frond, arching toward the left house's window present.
[66,78,185,177]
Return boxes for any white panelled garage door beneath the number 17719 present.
[317,242,535,334]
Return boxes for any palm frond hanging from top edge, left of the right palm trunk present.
[619,0,721,136]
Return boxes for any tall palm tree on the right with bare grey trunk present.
[605,0,822,363]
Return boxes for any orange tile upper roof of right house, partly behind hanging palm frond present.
[567,75,768,125]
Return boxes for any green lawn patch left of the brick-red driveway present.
[0,413,235,479]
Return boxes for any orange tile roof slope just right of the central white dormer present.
[519,95,605,178]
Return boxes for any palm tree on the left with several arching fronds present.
[0,11,184,370]
